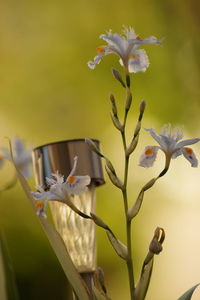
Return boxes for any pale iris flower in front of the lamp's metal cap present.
[32,156,91,216]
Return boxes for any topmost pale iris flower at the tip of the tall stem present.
[88,27,161,73]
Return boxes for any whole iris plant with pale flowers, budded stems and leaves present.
[0,27,200,300]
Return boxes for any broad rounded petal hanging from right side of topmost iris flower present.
[128,49,149,73]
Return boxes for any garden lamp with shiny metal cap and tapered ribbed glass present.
[33,140,104,273]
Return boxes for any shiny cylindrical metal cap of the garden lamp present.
[32,139,105,186]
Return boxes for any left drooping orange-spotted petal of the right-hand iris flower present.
[139,146,159,168]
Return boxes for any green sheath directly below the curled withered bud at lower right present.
[134,256,153,300]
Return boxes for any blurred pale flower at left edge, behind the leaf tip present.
[0,137,32,178]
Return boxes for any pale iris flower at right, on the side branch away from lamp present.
[139,124,200,168]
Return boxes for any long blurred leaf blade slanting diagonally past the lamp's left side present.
[10,141,89,300]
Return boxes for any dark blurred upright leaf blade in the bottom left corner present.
[0,232,19,300]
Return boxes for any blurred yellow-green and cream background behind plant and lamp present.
[0,0,200,300]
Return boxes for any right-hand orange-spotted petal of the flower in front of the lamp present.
[66,175,91,195]
